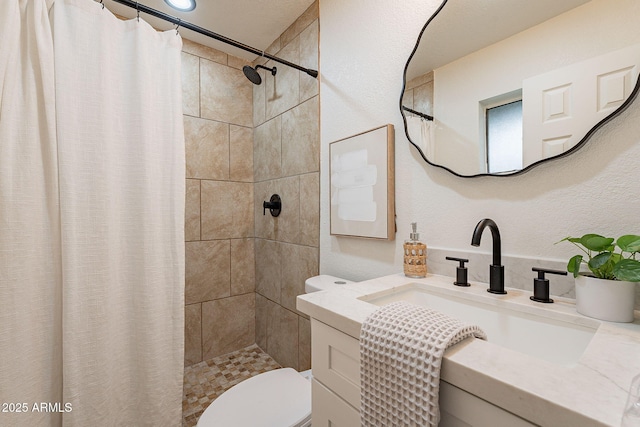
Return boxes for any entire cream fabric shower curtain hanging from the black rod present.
[0,0,185,426]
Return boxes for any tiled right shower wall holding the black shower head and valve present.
[253,1,320,370]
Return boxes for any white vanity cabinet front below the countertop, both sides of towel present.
[311,318,534,427]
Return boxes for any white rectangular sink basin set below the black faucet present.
[360,283,599,365]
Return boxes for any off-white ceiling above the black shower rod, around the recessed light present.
[104,0,314,61]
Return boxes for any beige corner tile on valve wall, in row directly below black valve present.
[255,239,282,304]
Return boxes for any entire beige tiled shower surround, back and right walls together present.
[182,2,320,370]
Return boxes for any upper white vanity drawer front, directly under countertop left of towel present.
[311,319,360,410]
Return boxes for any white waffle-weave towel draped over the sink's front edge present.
[360,301,487,427]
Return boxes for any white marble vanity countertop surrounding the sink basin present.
[297,274,640,427]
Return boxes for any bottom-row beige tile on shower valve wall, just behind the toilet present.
[267,303,298,370]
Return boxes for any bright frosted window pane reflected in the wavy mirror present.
[486,100,522,173]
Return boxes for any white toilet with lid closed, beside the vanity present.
[197,274,353,427]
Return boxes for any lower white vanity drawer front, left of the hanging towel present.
[311,380,360,427]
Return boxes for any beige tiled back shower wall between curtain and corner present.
[182,39,255,366]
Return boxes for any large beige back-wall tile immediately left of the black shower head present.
[200,59,253,126]
